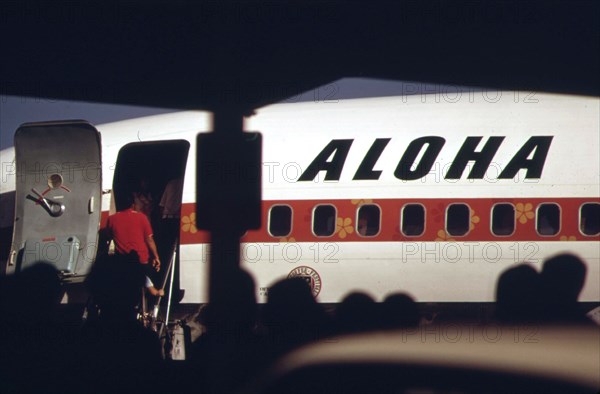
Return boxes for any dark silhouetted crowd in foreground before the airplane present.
[0,254,591,394]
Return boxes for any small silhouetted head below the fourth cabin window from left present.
[380,293,421,329]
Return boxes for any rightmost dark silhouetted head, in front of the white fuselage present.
[541,253,587,303]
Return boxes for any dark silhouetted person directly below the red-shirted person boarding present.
[77,256,163,393]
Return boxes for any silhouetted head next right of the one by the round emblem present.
[335,292,377,333]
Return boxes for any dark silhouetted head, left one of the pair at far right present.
[496,264,540,323]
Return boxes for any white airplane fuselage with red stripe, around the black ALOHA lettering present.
[0,92,600,303]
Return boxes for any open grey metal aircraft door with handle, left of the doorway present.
[6,121,102,282]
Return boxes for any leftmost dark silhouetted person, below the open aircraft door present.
[0,262,77,393]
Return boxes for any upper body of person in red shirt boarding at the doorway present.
[105,194,160,271]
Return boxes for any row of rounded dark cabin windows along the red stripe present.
[269,203,600,237]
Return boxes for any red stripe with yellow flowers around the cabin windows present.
[171,198,600,244]
